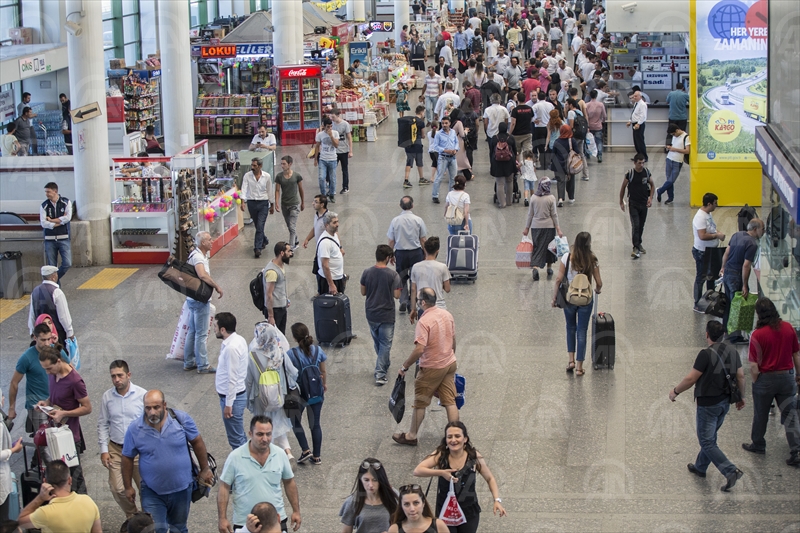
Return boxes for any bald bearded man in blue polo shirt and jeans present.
[122,390,214,533]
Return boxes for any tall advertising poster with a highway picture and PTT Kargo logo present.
[696,0,767,162]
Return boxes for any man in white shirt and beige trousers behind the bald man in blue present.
[97,359,147,525]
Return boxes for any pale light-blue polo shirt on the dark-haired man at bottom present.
[219,441,294,524]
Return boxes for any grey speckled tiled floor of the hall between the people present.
[0,101,800,533]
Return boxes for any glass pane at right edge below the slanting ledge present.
[756,182,800,328]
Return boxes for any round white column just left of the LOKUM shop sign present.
[158,0,194,155]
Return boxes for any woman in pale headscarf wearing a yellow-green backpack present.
[245,322,297,467]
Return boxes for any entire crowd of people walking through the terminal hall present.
[0,0,800,533]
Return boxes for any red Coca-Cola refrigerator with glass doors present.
[274,65,322,146]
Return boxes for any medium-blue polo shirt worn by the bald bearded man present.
[122,409,197,492]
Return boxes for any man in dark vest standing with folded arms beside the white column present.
[39,181,72,284]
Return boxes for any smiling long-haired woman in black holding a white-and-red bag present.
[414,422,506,533]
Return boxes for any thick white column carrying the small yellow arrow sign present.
[66,0,111,265]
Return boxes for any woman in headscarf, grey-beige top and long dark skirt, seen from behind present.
[522,177,564,281]
